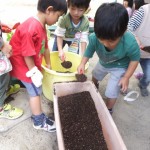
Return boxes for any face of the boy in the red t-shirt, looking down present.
[46,11,63,25]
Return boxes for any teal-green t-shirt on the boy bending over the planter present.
[84,32,140,68]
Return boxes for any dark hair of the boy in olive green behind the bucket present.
[67,0,91,9]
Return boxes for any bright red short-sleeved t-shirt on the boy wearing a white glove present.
[10,17,48,83]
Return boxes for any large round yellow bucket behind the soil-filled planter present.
[42,52,89,100]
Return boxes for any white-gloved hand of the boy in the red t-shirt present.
[26,66,43,87]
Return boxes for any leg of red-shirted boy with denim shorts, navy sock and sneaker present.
[22,81,56,132]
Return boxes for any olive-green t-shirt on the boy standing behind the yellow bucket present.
[58,13,89,38]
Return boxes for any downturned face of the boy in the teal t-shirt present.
[99,37,120,50]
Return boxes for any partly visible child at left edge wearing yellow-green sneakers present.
[0,23,23,120]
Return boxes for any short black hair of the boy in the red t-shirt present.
[37,0,67,13]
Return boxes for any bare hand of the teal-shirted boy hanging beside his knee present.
[119,77,129,93]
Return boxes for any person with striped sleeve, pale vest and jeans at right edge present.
[128,4,150,96]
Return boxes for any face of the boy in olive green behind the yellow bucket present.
[69,6,86,21]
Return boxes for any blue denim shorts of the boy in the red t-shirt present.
[21,81,42,97]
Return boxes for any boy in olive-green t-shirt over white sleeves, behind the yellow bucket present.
[53,0,90,61]
